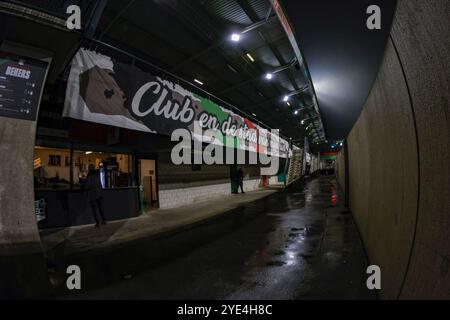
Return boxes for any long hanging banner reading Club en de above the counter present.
[63,49,289,158]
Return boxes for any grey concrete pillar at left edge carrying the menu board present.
[0,43,51,299]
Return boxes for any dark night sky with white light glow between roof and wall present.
[282,0,396,139]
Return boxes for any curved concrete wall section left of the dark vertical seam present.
[348,43,418,298]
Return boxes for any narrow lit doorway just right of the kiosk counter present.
[138,159,158,211]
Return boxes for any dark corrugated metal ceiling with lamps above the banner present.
[90,0,324,139]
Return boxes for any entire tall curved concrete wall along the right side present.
[337,0,450,299]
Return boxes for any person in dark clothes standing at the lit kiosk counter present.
[85,164,106,228]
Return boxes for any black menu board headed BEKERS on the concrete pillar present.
[0,51,48,121]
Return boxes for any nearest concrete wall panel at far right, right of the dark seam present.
[392,0,450,298]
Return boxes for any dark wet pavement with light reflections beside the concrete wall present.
[61,177,375,299]
